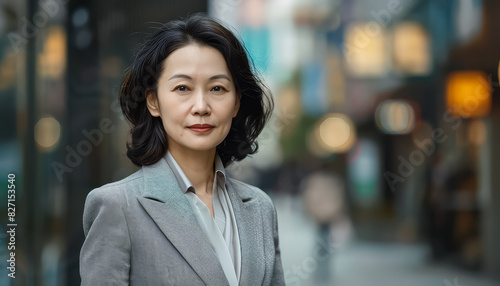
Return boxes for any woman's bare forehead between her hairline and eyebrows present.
[163,44,231,76]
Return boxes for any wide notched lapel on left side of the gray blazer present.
[138,158,229,285]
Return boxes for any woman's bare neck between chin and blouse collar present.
[168,146,215,195]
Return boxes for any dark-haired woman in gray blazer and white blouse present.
[80,15,284,285]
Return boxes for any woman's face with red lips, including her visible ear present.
[147,44,240,154]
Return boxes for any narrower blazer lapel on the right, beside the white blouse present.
[226,179,265,285]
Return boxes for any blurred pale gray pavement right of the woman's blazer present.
[274,196,500,286]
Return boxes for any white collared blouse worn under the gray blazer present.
[165,151,241,285]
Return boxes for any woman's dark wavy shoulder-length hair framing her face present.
[120,14,274,166]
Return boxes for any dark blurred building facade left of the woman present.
[0,0,207,285]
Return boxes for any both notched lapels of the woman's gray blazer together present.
[138,158,265,285]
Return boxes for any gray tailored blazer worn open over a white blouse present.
[80,158,285,286]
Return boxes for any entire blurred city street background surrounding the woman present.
[0,0,500,286]
